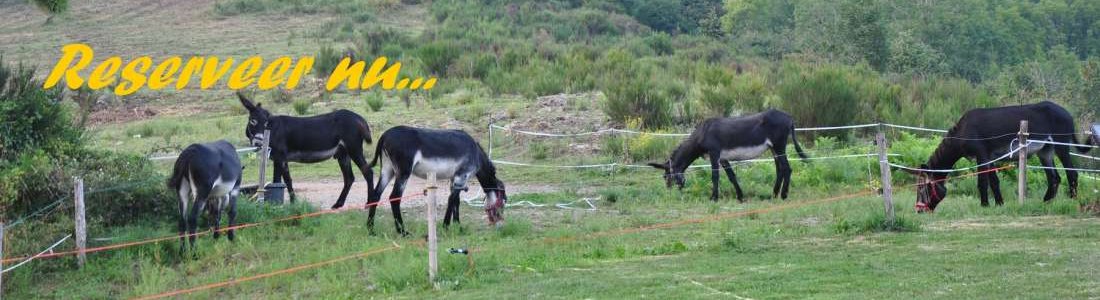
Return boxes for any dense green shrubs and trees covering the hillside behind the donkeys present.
[253,0,1100,127]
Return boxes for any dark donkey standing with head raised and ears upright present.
[237,92,374,209]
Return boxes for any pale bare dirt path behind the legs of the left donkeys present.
[294,177,558,209]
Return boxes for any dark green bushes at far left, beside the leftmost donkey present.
[0,59,175,224]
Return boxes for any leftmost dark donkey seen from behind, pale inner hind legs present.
[168,140,241,252]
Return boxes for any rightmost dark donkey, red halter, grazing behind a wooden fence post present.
[909,101,1089,212]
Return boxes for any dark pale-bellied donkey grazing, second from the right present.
[649,109,806,201]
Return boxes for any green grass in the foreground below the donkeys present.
[4,181,1100,299]
